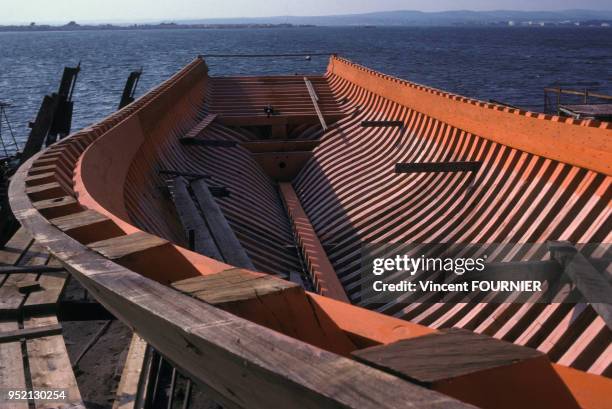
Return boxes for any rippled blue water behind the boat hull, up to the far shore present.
[0,27,612,151]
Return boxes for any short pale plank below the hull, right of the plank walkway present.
[113,334,147,409]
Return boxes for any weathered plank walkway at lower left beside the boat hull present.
[0,229,84,409]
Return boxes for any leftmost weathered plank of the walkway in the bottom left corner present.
[0,321,28,409]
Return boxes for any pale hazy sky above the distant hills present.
[0,0,612,23]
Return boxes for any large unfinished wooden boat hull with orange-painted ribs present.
[9,56,612,408]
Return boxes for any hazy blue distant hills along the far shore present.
[177,10,612,26]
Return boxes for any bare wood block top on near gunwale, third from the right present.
[88,231,168,260]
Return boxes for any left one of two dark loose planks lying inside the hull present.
[172,176,223,261]
